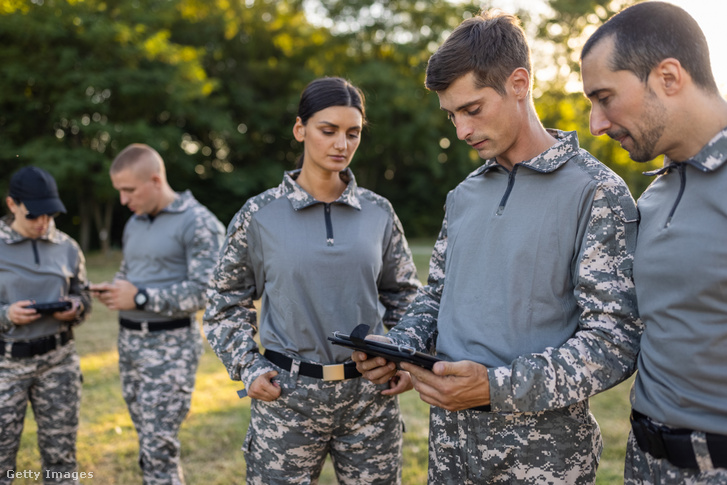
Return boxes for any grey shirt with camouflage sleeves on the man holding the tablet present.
[388,130,642,412]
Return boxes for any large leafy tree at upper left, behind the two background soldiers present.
[0,0,225,248]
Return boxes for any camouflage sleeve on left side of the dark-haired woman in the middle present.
[203,201,274,388]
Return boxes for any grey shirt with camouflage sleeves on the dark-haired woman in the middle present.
[204,170,420,386]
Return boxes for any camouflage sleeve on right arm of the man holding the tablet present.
[488,185,642,412]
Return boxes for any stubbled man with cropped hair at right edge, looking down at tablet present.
[581,2,727,485]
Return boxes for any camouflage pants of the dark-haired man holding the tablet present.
[429,401,603,485]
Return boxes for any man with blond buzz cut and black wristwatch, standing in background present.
[92,144,224,485]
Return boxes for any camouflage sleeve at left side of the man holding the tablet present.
[386,205,447,353]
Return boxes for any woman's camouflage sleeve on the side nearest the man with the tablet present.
[379,209,421,328]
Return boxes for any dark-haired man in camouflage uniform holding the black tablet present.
[354,12,641,485]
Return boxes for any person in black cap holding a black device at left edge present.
[0,167,91,483]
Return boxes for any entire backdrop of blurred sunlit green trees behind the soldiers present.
[0,0,649,250]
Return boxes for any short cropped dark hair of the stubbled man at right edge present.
[581,2,719,93]
